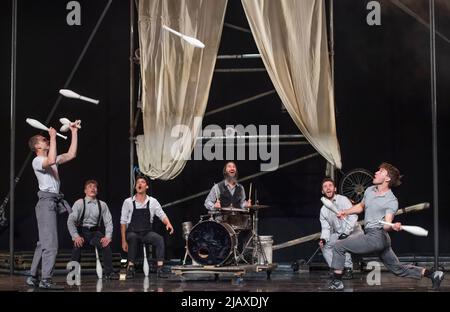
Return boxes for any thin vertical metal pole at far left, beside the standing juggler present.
[9,0,17,275]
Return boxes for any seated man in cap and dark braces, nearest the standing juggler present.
[67,180,119,280]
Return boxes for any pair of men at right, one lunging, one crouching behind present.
[319,163,444,290]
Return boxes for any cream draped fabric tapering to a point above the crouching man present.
[242,0,342,168]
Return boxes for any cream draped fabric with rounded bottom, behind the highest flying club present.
[136,0,227,180]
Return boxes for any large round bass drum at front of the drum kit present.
[187,221,237,266]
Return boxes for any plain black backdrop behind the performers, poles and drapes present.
[0,0,450,261]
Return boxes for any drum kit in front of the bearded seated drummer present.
[182,205,272,266]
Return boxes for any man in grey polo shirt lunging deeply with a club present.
[329,163,444,290]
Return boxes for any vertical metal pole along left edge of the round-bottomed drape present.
[130,0,134,196]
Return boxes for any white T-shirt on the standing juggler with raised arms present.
[32,156,61,194]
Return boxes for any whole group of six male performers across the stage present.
[26,126,444,290]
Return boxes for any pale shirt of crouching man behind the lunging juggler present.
[320,194,358,241]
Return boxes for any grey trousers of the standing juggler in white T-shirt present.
[30,191,66,279]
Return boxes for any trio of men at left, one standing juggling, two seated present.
[26,123,173,290]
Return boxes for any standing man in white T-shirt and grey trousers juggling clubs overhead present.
[26,123,78,290]
